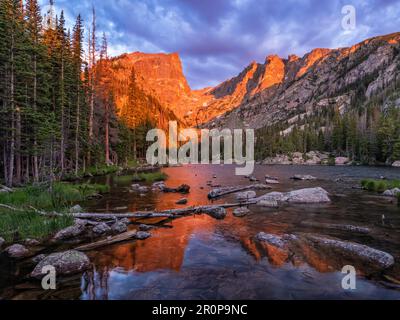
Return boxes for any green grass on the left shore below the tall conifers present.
[0,182,109,242]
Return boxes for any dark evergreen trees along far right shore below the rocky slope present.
[256,76,400,164]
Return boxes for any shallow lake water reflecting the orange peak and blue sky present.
[0,165,400,299]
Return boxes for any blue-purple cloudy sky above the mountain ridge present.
[39,0,400,88]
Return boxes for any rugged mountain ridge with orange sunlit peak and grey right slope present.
[97,33,400,128]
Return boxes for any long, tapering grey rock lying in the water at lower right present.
[305,235,394,269]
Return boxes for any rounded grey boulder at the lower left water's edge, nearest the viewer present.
[31,250,90,279]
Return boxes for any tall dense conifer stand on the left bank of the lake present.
[0,0,144,186]
